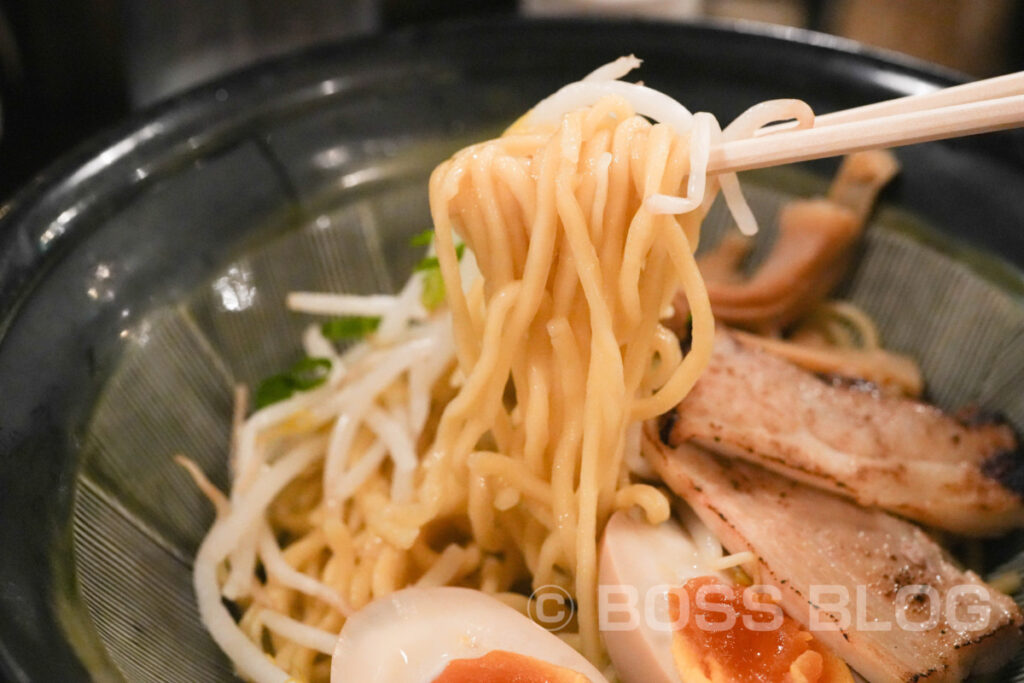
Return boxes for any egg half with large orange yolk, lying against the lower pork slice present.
[598,511,853,683]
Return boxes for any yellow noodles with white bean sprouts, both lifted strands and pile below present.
[194,57,782,683]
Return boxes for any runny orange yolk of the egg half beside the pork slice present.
[670,577,853,683]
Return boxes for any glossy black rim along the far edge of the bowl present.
[0,17,969,329]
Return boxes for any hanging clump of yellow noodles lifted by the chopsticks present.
[430,95,714,661]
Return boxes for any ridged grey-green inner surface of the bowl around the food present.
[73,168,1024,682]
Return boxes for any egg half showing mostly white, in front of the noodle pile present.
[331,587,607,683]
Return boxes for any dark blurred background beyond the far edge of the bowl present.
[0,0,1024,201]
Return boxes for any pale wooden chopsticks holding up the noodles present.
[708,72,1024,173]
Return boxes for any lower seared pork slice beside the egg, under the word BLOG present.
[646,436,1024,683]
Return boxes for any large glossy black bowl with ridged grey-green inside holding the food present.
[0,15,1024,681]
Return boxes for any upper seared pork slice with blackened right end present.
[662,331,1024,536]
